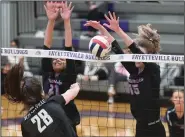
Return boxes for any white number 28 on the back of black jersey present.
[31,109,53,133]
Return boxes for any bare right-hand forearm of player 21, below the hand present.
[64,19,72,47]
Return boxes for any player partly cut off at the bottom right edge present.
[166,90,184,137]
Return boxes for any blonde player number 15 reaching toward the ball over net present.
[85,12,166,137]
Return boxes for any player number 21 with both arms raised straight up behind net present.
[42,1,80,131]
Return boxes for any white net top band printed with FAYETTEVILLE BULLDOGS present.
[1,48,184,64]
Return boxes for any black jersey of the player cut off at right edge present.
[166,108,184,137]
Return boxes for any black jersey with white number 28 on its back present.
[21,95,76,137]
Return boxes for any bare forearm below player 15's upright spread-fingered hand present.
[116,27,133,47]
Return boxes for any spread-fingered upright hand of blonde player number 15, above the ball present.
[103,11,119,32]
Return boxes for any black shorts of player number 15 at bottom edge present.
[135,121,166,137]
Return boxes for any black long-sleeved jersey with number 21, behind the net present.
[42,46,80,125]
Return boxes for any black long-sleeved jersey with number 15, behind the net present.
[112,41,160,123]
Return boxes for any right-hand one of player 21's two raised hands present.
[60,1,74,20]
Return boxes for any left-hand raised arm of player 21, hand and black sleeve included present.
[42,2,59,72]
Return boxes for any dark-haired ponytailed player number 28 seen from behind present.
[5,63,80,137]
